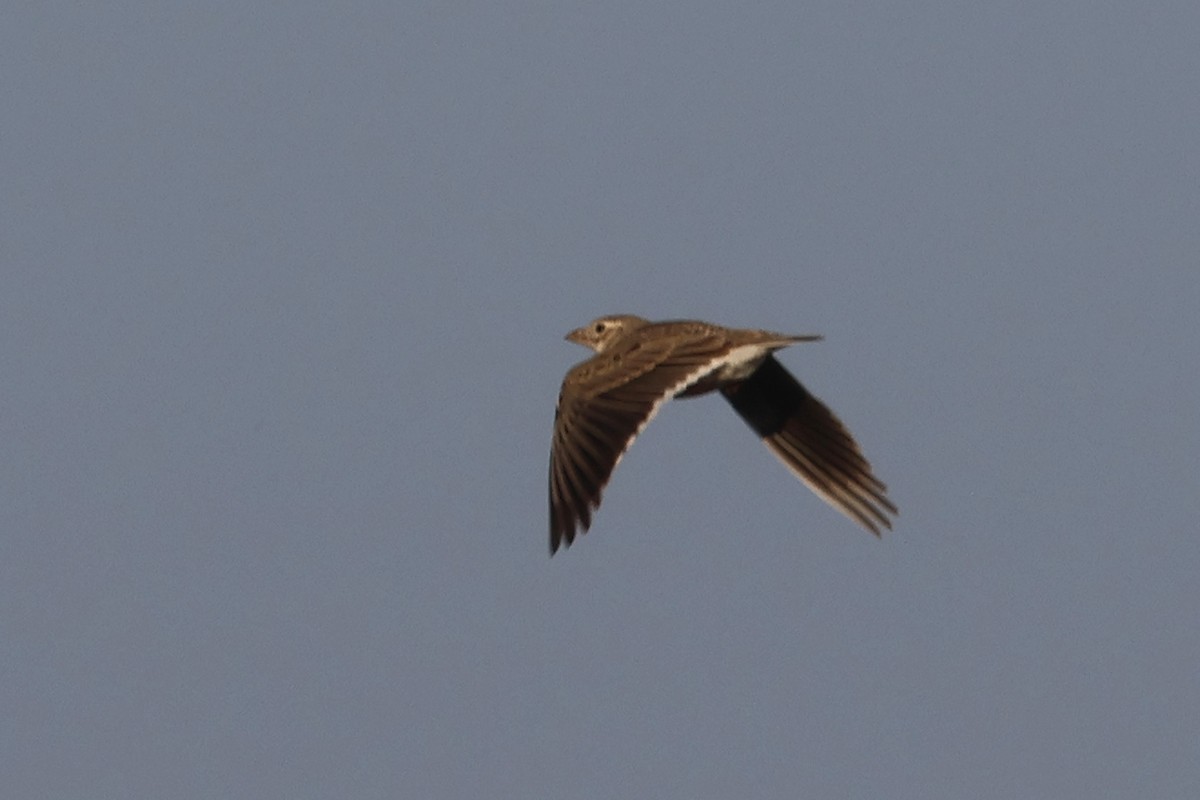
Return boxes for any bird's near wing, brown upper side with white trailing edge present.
[550,333,728,554]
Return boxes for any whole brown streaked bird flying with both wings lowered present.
[550,314,898,555]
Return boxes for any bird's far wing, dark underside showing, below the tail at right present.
[721,356,898,536]
